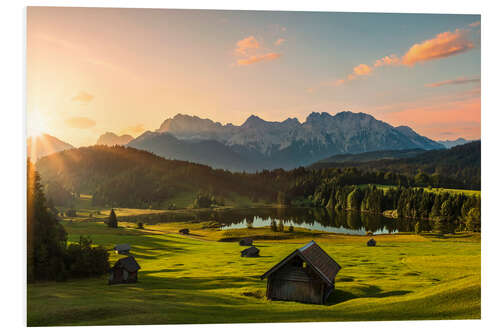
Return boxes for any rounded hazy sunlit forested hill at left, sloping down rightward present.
[37,146,280,207]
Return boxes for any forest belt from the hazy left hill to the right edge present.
[37,142,481,231]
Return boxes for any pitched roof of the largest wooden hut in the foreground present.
[261,241,341,285]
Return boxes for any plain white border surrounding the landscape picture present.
[0,0,500,333]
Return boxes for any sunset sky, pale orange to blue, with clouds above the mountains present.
[26,7,481,146]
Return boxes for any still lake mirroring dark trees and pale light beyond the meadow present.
[217,208,406,235]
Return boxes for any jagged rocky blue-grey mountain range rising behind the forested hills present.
[127,111,445,171]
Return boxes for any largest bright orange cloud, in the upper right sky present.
[402,29,474,66]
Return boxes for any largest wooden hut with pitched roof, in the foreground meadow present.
[261,241,341,304]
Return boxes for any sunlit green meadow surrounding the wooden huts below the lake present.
[27,218,481,326]
